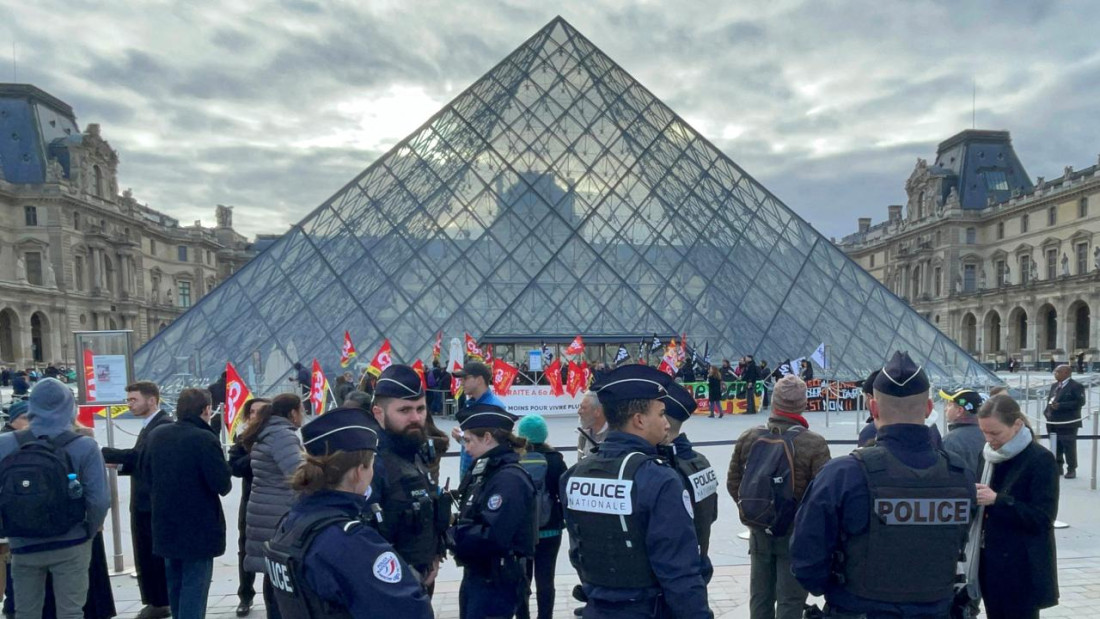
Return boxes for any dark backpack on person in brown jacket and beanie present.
[737,425,803,538]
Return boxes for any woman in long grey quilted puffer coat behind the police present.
[241,394,303,619]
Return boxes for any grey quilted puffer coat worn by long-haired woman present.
[244,417,303,574]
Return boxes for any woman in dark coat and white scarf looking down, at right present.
[978,396,1058,619]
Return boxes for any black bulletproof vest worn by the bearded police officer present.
[378,450,440,568]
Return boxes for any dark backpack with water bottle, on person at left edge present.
[0,430,85,538]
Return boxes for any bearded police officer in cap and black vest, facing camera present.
[371,364,451,594]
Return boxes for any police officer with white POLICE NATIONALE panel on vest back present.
[561,365,713,619]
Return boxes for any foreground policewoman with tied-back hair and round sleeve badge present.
[264,409,432,619]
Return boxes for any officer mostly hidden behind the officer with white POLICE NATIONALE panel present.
[662,373,718,582]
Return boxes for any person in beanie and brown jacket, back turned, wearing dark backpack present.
[726,375,831,619]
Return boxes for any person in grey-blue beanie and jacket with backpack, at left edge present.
[0,378,110,619]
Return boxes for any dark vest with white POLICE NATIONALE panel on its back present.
[562,452,658,589]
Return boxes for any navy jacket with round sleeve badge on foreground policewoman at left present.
[286,490,432,619]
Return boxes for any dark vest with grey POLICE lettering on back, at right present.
[842,446,974,604]
